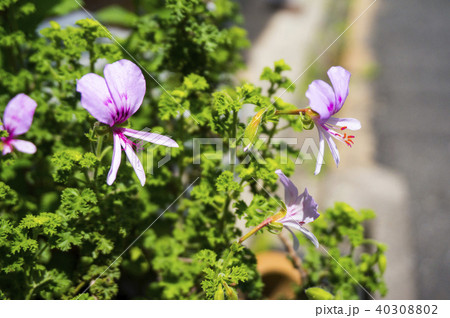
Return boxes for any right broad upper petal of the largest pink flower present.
[103,60,145,123]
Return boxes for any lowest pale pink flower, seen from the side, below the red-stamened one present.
[275,170,320,249]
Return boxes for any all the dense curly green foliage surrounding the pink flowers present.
[0,0,386,299]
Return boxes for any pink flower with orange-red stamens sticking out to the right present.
[306,66,361,174]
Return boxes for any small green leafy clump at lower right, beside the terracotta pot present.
[299,203,387,299]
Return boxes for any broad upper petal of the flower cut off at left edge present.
[3,94,37,137]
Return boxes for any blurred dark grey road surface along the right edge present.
[372,0,450,299]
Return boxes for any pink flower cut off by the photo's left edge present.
[0,94,37,155]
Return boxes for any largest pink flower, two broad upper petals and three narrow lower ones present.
[77,60,178,186]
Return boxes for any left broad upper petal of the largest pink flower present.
[77,73,117,126]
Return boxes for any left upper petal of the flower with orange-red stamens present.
[306,80,335,122]
